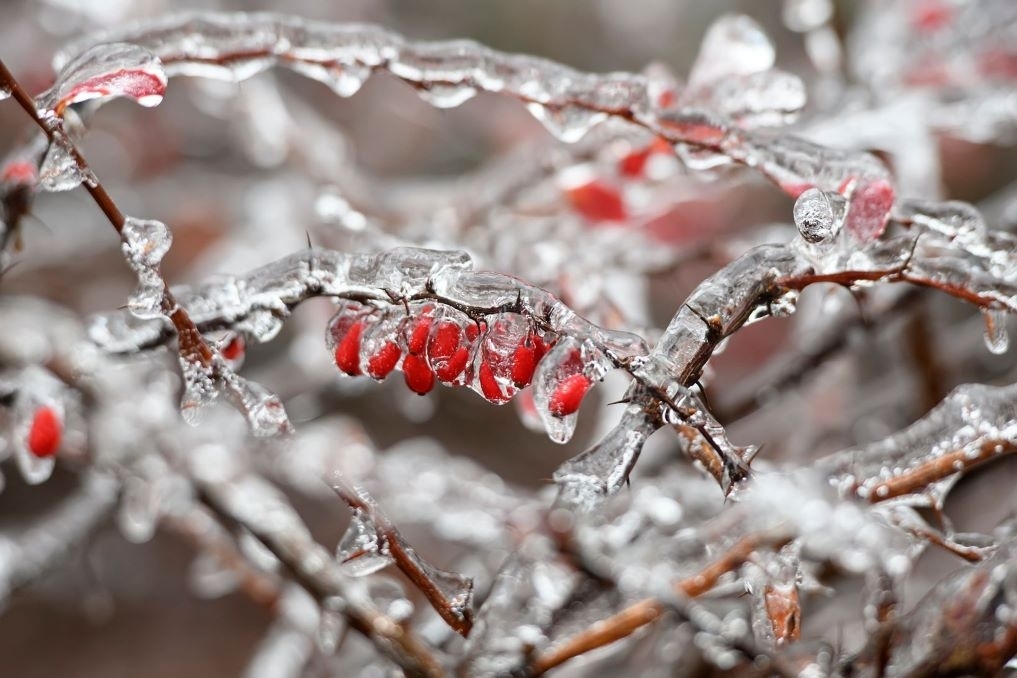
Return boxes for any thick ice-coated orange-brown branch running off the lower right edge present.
[817,384,1017,506]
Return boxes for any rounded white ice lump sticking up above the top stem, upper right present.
[689,14,777,87]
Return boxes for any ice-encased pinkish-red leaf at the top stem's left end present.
[39,43,166,115]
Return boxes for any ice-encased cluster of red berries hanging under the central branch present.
[327,302,592,417]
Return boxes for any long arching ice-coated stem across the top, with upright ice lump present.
[49,12,888,200]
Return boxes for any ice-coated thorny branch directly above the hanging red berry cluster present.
[89,247,646,359]
